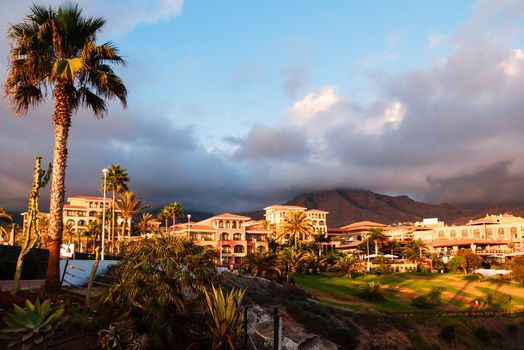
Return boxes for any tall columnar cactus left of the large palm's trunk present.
[11,156,52,295]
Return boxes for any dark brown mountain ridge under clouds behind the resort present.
[244,189,524,227]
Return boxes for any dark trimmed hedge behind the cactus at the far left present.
[0,245,49,280]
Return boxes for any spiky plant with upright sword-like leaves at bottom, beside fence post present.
[204,285,245,350]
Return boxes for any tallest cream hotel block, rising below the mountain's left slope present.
[264,205,329,234]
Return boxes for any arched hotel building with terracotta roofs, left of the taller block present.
[172,213,271,266]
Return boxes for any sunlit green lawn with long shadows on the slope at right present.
[293,272,524,312]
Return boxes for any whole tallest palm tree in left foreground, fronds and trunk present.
[4,5,127,291]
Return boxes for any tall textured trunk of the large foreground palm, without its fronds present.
[45,81,75,292]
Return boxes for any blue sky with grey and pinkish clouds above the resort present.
[0,0,524,212]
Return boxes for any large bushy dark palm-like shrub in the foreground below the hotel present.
[99,236,216,340]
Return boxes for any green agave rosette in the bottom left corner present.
[0,299,64,350]
